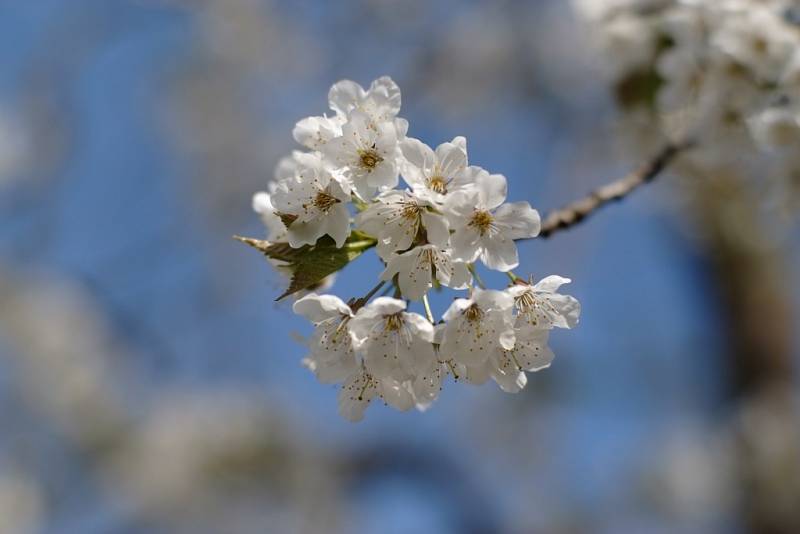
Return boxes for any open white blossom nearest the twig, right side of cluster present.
[445,167,541,271]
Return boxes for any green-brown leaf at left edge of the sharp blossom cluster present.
[234,231,376,300]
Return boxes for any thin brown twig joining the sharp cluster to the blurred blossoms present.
[539,140,695,237]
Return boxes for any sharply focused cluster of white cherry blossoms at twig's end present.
[253,77,580,421]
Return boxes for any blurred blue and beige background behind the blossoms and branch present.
[0,0,800,534]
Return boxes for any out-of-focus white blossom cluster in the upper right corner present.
[573,0,800,182]
